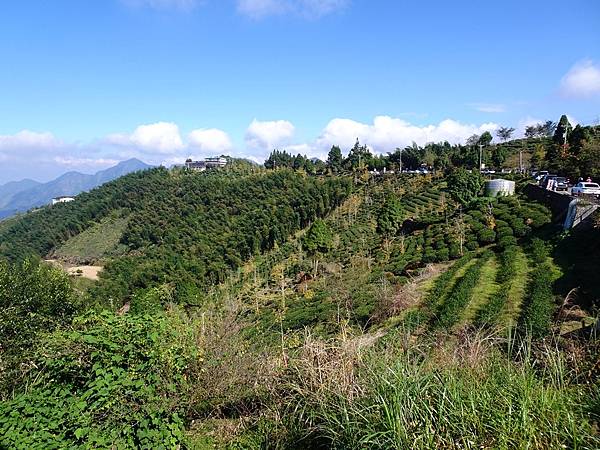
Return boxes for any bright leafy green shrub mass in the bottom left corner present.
[0,312,198,448]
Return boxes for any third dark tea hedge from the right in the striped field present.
[436,250,494,328]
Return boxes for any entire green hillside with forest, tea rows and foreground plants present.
[0,154,600,449]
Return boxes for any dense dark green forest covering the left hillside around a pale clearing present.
[0,168,352,299]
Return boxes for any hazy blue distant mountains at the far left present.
[0,158,152,220]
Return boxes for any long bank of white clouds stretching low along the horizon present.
[0,116,506,182]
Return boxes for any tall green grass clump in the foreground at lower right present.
[266,332,600,449]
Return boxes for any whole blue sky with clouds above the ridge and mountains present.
[0,0,600,183]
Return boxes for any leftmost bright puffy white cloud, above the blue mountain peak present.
[106,122,184,154]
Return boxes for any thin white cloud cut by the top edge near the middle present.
[237,0,349,19]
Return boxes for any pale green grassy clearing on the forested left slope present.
[52,213,129,263]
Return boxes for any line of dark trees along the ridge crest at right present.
[265,115,600,180]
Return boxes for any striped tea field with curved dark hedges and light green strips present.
[404,241,556,335]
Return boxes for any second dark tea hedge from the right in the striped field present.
[475,245,517,327]
